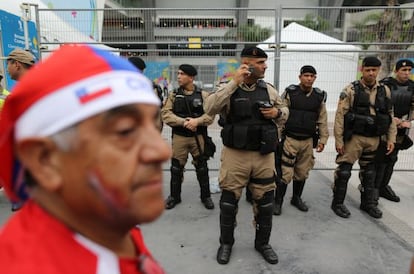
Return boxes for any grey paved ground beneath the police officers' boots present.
[0,170,414,274]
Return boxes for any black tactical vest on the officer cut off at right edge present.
[381,77,414,136]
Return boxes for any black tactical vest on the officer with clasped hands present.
[172,86,207,137]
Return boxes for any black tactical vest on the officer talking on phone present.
[221,80,278,154]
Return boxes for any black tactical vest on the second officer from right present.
[345,81,392,137]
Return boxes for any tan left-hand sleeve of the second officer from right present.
[334,85,353,147]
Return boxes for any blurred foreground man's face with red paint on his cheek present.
[55,104,171,227]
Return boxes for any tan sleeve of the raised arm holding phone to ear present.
[204,80,237,117]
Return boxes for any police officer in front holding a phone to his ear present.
[206,47,289,264]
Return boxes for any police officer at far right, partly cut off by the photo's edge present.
[376,59,414,202]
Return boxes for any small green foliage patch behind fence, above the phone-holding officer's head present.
[224,24,273,42]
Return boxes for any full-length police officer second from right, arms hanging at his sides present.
[331,56,397,218]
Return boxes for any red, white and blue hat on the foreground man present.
[0,45,160,202]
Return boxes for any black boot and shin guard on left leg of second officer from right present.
[331,163,352,218]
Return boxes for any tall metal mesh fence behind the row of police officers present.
[35,6,414,170]
